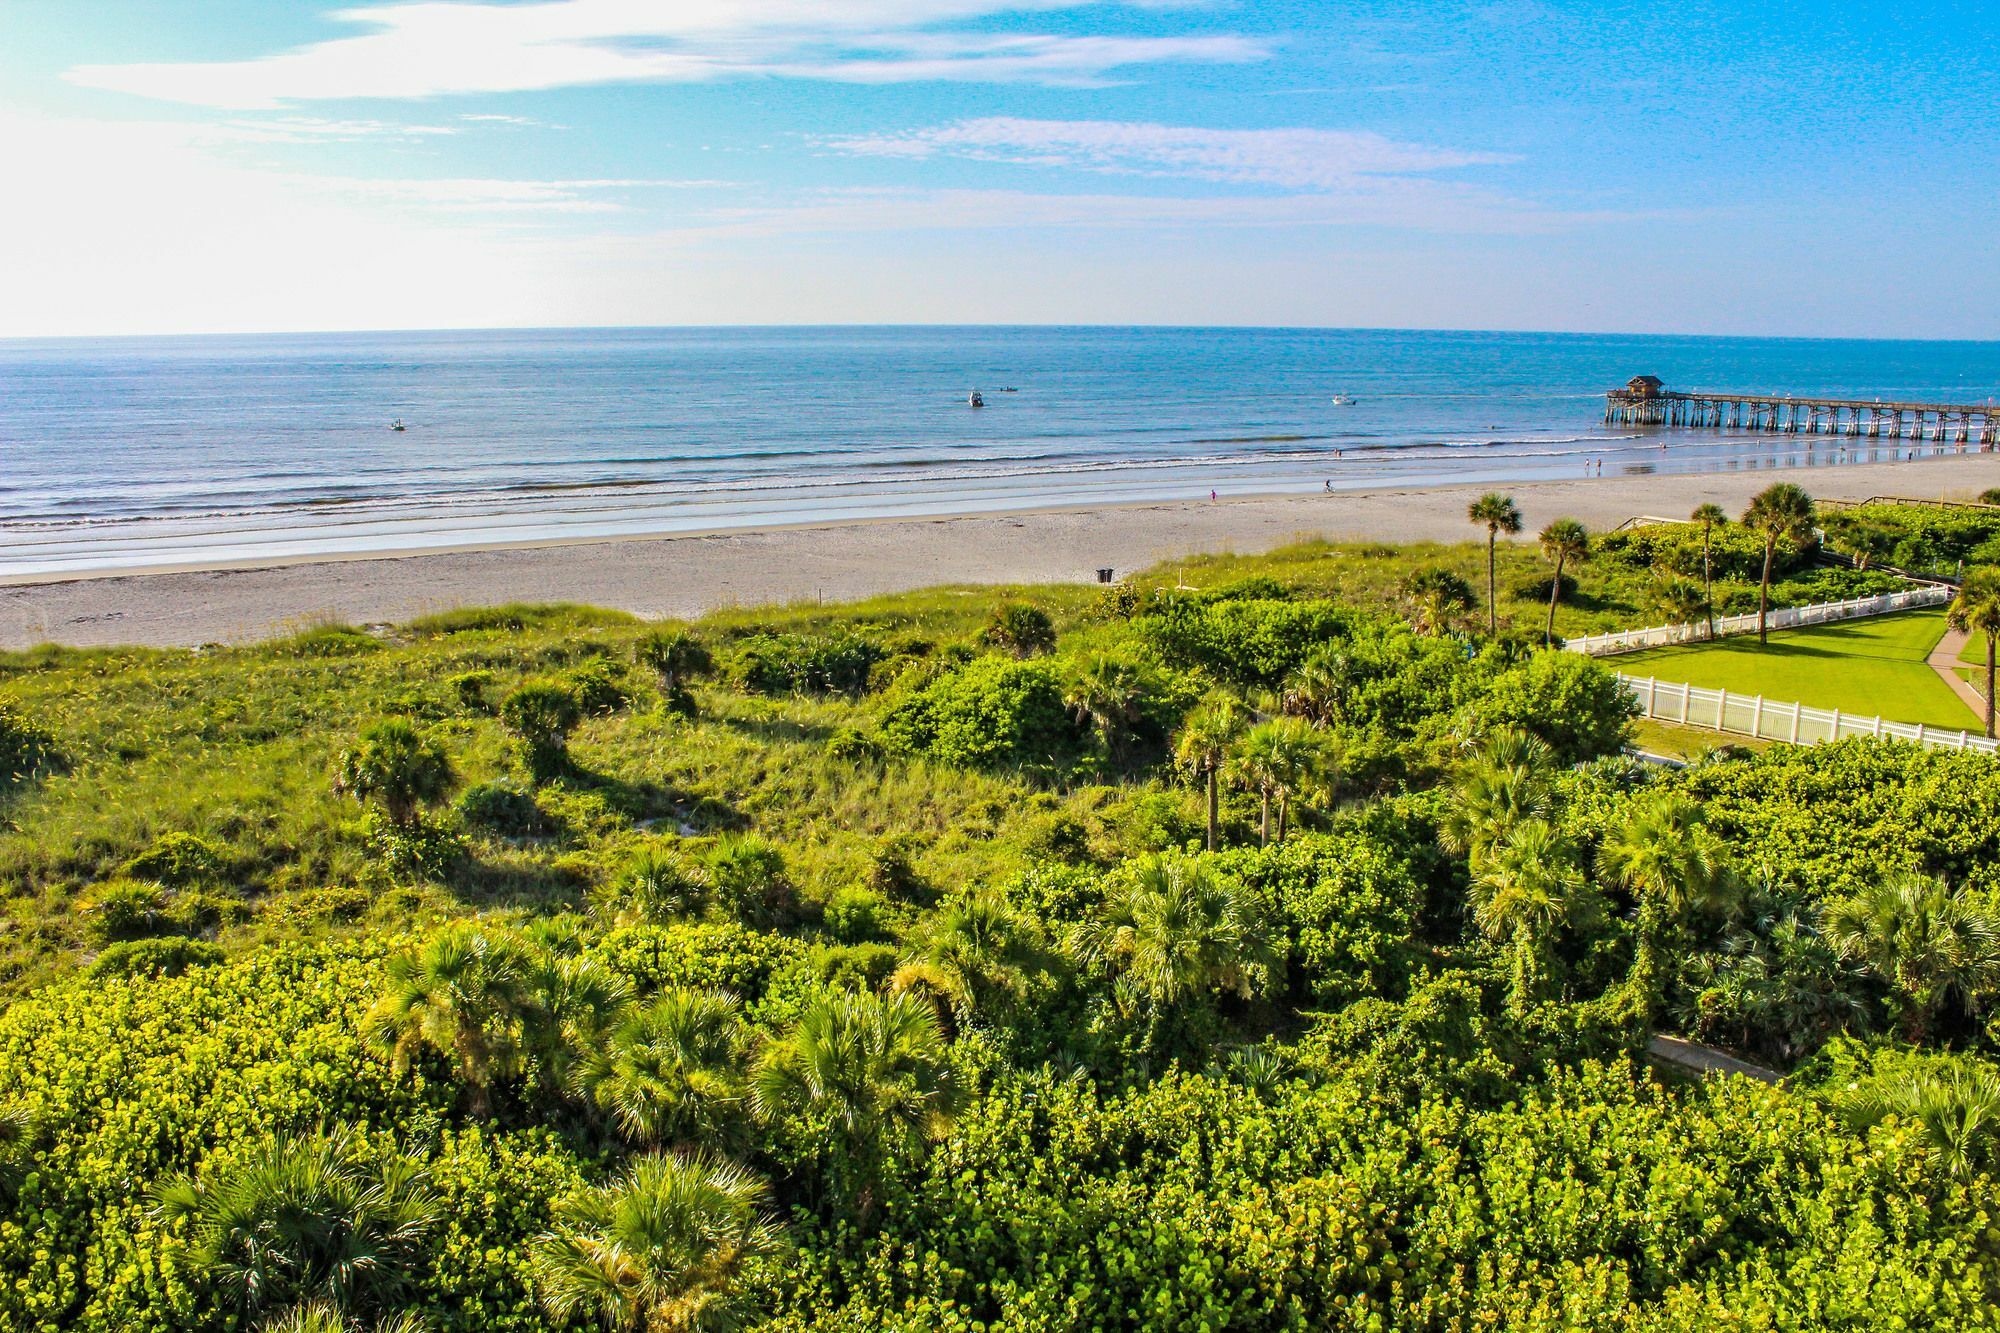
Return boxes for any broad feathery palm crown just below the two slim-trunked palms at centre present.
[1070,855,1278,1015]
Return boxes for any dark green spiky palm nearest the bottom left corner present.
[154,1127,440,1319]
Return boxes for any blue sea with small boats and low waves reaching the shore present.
[0,328,2000,574]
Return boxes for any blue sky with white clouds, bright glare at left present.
[0,0,2000,338]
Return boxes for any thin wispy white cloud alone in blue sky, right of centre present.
[826,116,1512,190]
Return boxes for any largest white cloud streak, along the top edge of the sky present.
[68,0,1266,110]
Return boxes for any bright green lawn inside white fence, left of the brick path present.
[1608,610,1980,729]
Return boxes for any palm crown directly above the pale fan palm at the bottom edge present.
[572,987,750,1151]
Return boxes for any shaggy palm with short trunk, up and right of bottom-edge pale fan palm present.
[752,993,960,1223]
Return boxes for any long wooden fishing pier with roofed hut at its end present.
[1604,374,2000,448]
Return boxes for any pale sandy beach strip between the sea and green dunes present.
[0,454,2000,648]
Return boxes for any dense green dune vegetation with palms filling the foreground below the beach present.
[11,522,2000,1333]
